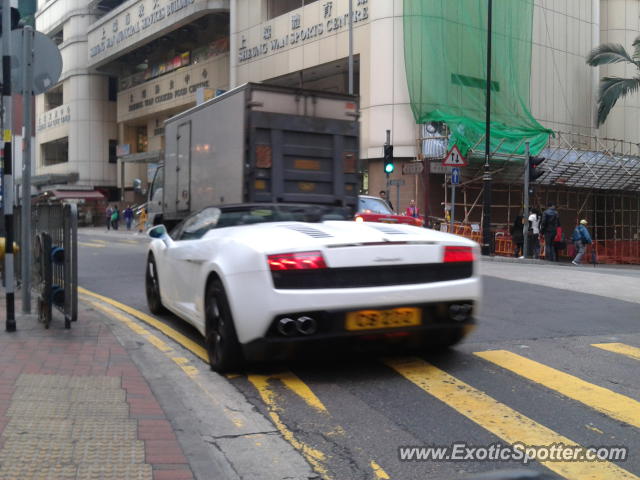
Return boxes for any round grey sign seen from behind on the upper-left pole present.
[0,29,62,95]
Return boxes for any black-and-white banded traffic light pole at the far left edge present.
[2,0,15,332]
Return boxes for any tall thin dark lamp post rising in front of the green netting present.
[482,0,493,255]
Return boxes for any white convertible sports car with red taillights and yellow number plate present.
[146,204,481,371]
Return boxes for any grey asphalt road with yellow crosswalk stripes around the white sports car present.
[80,231,640,480]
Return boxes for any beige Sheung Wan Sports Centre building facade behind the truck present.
[36,0,640,219]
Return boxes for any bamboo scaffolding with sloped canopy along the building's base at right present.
[420,128,640,264]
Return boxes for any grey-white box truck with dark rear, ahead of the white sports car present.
[147,83,360,228]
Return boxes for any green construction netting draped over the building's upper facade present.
[404,0,552,155]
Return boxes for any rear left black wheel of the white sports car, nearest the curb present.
[205,280,244,373]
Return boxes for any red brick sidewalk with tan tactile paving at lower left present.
[0,295,194,480]
